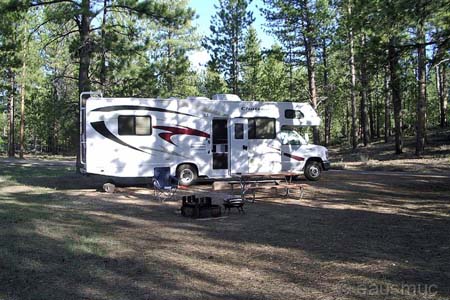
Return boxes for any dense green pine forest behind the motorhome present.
[0,0,450,157]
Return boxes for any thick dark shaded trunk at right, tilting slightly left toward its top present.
[388,37,403,154]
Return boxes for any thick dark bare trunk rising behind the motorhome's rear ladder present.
[76,0,92,172]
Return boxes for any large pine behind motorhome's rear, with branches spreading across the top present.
[0,0,193,169]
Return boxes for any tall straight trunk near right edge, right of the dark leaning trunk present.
[416,19,427,156]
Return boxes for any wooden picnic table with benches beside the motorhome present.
[228,172,306,202]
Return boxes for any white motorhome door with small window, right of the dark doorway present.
[228,118,248,174]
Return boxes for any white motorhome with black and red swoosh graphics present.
[80,93,330,185]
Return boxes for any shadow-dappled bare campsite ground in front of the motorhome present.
[0,159,450,300]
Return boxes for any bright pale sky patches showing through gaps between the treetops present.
[185,0,275,70]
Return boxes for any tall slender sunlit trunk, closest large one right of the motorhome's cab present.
[348,4,358,150]
